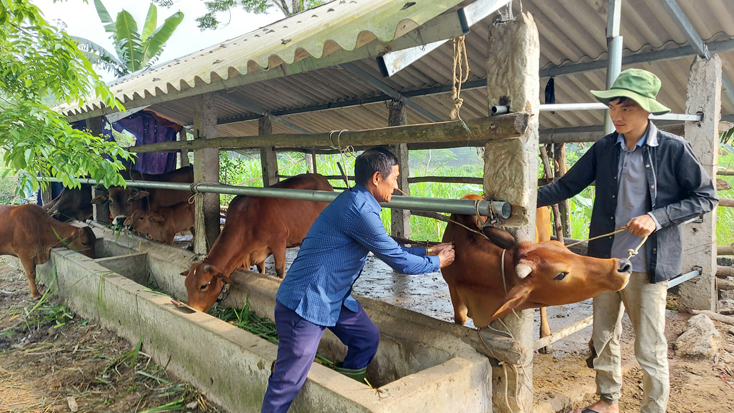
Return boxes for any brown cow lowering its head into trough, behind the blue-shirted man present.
[181,174,333,311]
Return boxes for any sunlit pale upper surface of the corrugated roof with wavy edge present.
[60,0,461,114]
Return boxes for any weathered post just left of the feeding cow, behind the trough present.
[194,93,219,254]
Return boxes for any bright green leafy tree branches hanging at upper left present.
[0,0,130,190]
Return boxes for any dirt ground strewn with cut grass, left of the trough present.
[0,259,225,413]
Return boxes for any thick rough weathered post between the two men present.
[484,13,540,413]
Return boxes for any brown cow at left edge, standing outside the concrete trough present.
[0,204,97,299]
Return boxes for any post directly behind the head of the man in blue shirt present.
[387,100,410,238]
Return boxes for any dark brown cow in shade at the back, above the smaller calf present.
[92,166,194,225]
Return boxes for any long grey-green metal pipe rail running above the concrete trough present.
[48,178,512,219]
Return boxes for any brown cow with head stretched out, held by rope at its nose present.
[441,195,632,328]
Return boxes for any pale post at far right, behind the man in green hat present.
[678,56,721,311]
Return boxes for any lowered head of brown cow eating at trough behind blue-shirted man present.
[181,262,232,312]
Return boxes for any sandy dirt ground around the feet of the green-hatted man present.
[533,295,734,413]
